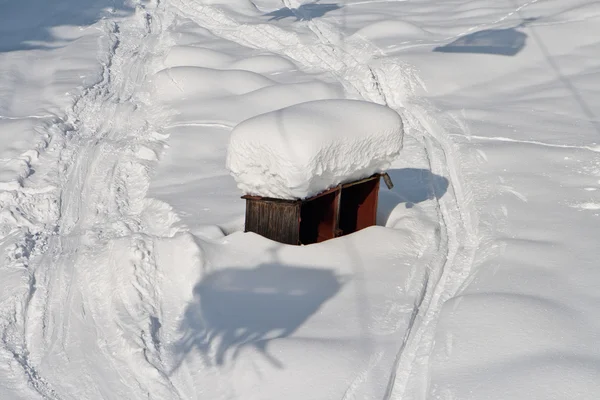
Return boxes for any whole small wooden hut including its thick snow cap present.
[227,100,403,244]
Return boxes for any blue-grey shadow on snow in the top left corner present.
[0,0,134,52]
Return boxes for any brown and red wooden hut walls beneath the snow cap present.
[242,174,392,245]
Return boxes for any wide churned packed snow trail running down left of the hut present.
[0,2,190,399]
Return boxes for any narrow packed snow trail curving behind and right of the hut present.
[173,0,479,399]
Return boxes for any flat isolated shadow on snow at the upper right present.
[433,18,537,56]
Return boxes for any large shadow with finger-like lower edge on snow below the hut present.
[173,264,343,370]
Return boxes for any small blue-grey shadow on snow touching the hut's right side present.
[377,168,448,225]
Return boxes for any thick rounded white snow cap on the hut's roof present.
[227,100,403,199]
